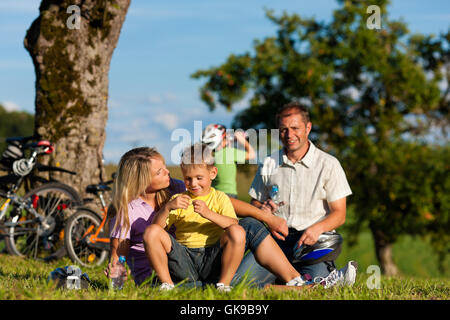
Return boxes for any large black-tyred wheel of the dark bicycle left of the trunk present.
[5,182,82,260]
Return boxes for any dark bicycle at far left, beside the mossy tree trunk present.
[0,137,82,260]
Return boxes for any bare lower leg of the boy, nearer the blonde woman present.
[143,224,173,284]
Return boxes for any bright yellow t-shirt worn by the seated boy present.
[166,188,237,248]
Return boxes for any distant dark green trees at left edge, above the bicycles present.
[0,104,34,154]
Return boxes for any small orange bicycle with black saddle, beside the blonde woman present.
[64,174,114,267]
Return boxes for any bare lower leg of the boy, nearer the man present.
[219,224,245,286]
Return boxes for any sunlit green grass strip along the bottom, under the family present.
[0,254,450,300]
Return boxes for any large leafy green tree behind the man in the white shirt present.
[192,0,450,275]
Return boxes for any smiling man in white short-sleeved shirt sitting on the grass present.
[238,102,356,282]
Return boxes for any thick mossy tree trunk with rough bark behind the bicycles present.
[24,0,130,193]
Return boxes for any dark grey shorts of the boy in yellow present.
[167,234,222,283]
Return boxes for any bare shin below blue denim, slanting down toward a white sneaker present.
[254,236,300,282]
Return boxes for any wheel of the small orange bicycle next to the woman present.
[64,208,108,267]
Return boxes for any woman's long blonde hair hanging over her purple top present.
[108,147,169,237]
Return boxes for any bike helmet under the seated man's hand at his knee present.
[293,232,343,266]
